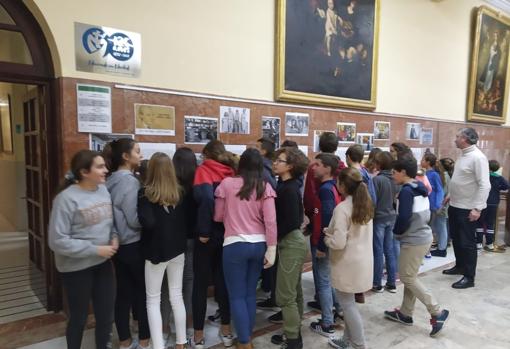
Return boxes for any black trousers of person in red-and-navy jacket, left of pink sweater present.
[193,239,230,331]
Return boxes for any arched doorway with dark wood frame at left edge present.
[0,0,62,323]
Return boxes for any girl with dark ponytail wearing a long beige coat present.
[324,168,374,348]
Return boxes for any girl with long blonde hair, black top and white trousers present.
[138,153,187,349]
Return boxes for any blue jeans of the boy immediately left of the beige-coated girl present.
[311,246,341,326]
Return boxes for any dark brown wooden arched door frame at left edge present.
[0,0,62,311]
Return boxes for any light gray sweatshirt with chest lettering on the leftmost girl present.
[48,184,113,273]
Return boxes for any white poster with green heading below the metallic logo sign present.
[76,84,112,133]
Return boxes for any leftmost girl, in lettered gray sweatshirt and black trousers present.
[48,150,118,349]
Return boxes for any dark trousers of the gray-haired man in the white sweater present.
[448,206,478,280]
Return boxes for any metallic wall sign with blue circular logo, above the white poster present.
[74,23,142,77]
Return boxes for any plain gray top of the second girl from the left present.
[106,170,142,245]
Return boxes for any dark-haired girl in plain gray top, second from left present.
[106,138,150,349]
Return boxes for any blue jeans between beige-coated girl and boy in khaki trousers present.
[373,221,397,286]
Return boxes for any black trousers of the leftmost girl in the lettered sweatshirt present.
[60,261,115,349]
